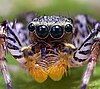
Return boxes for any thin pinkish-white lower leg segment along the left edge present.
[0,23,13,89]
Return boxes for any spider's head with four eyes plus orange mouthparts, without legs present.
[21,16,73,82]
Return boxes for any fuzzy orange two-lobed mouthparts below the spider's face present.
[24,48,70,83]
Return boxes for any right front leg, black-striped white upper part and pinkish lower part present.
[71,20,100,89]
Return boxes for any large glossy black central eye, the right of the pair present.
[50,25,64,38]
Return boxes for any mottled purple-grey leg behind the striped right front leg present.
[72,15,97,48]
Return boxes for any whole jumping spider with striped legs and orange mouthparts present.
[0,14,100,89]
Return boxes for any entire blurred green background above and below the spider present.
[0,0,100,89]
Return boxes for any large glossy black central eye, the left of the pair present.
[36,25,49,38]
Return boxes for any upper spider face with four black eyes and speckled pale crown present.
[28,16,73,42]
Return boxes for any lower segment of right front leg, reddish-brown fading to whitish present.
[81,42,100,89]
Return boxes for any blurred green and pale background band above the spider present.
[0,0,100,20]
